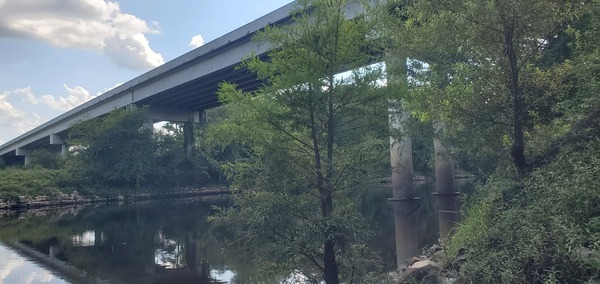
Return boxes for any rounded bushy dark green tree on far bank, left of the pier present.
[68,105,154,187]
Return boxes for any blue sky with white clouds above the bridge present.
[0,0,292,145]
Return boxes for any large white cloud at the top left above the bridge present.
[0,0,164,69]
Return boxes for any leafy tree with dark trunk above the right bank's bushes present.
[383,0,585,176]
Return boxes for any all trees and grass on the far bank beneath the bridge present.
[2,108,219,197]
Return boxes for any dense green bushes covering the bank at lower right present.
[448,108,600,283]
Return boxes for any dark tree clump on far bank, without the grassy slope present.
[67,108,217,191]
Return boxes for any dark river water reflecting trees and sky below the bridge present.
[0,181,472,284]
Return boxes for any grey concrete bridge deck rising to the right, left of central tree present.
[0,2,308,164]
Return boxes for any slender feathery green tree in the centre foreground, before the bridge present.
[209,0,388,284]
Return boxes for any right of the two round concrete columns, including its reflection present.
[433,122,460,241]
